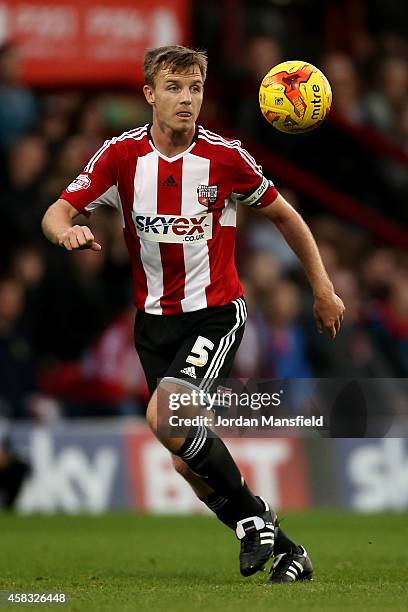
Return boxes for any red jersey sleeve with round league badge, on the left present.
[60,140,119,217]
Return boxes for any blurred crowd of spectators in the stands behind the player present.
[0,3,408,419]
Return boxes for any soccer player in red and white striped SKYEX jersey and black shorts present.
[42,46,344,584]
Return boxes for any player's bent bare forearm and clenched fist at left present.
[41,198,102,251]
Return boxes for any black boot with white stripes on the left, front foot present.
[235,497,278,576]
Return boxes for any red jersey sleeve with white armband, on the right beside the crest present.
[233,146,278,208]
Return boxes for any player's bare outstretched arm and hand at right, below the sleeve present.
[258,194,345,339]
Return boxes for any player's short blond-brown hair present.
[143,45,208,87]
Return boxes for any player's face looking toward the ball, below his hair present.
[144,66,204,132]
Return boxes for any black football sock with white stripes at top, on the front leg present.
[175,425,264,524]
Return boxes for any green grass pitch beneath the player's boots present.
[0,511,408,612]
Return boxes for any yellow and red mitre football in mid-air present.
[259,60,332,134]
